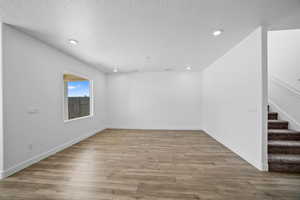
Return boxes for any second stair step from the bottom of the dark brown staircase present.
[268,140,300,155]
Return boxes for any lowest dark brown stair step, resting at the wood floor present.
[268,154,300,173]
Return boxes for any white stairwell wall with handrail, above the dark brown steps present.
[268,30,300,130]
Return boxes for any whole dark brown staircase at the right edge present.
[268,109,300,173]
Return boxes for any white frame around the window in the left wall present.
[61,71,94,123]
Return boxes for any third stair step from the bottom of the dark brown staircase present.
[268,129,300,141]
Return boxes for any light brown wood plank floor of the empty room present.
[0,130,300,200]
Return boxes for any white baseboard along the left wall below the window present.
[0,128,105,179]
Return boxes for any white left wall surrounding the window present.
[2,25,106,176]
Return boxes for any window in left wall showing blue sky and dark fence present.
[64,74,92,121]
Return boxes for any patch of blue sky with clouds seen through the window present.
[68,80,90,97]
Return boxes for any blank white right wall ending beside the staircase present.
[202,28,267,170]
